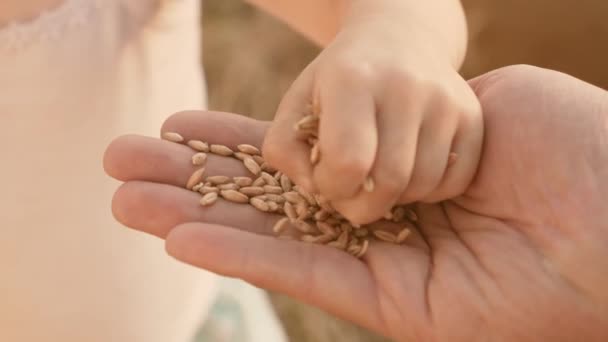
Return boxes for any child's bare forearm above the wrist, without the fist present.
[248,0,467,68]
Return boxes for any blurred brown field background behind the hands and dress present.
[203,0,608,342]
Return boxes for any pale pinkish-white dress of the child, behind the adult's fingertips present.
[0,0,280,342]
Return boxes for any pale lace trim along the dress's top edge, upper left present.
[0,0,104,52]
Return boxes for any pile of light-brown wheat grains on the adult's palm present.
[163,114,417,258]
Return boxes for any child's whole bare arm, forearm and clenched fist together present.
[245,0,483,223]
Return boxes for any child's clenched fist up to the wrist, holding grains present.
[264,16,483,223]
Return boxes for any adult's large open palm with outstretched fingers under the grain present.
[104,66,608,341]
